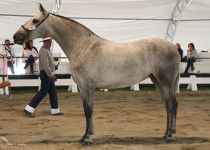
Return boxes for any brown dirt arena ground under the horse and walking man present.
[0,90,210,150]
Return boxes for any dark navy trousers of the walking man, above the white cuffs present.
[28,70,58,109]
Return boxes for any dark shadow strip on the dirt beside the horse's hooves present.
[27,137,210,145]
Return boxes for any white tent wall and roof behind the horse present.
[0,0,210,54]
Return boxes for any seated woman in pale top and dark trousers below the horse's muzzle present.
[21,42,38,73]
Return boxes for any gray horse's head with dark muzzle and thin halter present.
[13,3,50,45]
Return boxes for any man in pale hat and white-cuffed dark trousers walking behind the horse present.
[24,37,63,117]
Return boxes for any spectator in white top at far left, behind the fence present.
[3,39,15,74]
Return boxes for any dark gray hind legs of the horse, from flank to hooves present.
[150,75,178,143]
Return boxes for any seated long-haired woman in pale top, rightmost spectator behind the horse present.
[184,43,198,74]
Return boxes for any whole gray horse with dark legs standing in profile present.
[13,4,180,145]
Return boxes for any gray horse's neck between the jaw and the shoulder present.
[50,16,95,59]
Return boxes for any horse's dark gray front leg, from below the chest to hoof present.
[80,89,95,145]
